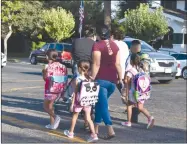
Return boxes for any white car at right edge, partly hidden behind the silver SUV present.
[171,53,187,79]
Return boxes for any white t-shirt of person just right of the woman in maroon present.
[114,40,129,77]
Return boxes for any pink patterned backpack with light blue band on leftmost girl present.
[47,62,68,94]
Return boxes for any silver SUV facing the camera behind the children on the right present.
[124,38,177,83]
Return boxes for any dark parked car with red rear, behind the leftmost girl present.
[29,43,73,67]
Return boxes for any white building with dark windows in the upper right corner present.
[160,0,187,52]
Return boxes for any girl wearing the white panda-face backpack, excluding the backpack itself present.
[64,60,98,142]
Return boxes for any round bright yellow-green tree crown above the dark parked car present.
[42,7,75,42]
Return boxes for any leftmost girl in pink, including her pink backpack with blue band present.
[42,49,67,129]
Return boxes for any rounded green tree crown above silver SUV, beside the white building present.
[122,4,169,42]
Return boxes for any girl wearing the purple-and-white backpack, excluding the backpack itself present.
[121,54,154,129]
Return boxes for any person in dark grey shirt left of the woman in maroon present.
[72,26,96,75]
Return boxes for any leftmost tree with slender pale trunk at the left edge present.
[1,0,23,56]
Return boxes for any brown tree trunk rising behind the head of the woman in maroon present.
[104,0,111,29]
